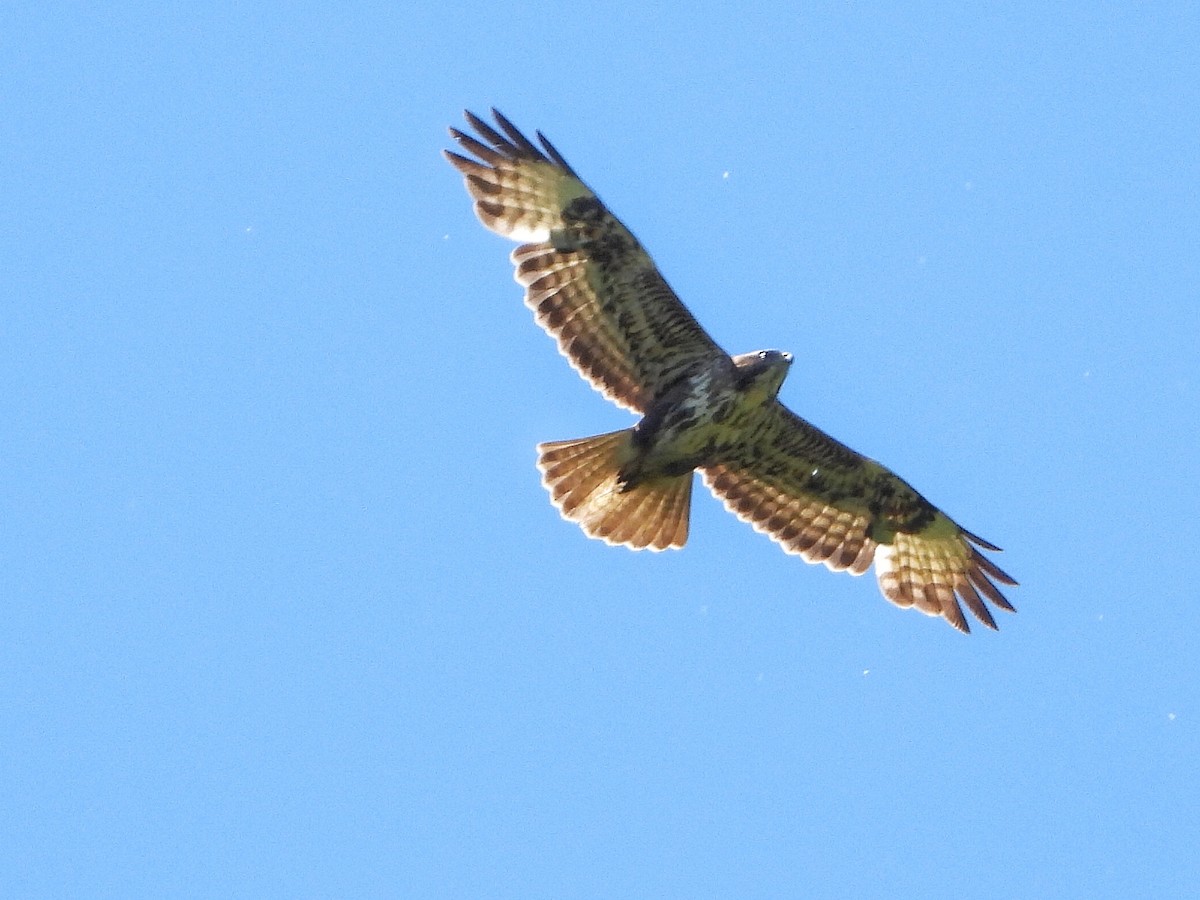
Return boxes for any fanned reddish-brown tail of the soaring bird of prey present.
[538,428,692,550]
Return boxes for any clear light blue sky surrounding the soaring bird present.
[0,2,1200,898]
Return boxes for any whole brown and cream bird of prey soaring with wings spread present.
[444,109,1016,632]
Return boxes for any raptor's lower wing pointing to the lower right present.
[702,403,1016,631]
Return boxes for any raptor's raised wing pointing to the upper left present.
[445,109,724,412]
